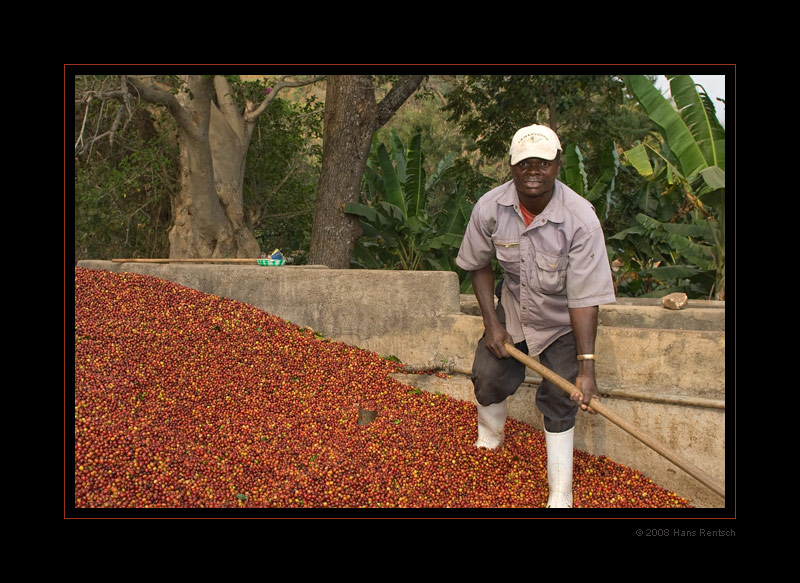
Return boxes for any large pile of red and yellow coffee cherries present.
[73,268,688,509]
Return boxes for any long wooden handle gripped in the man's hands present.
[505,343,725,498]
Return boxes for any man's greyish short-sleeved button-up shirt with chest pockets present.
[456,181,616,356]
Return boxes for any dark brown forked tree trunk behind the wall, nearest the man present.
[309,75,423,269]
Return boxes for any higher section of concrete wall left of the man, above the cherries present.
[78,261,461,338]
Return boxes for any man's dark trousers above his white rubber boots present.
[472,304,578,433]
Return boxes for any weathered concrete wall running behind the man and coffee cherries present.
[79,261,725,507]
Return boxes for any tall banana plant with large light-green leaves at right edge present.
[612,75,725,299]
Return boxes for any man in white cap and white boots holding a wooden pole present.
[456,125,615,508]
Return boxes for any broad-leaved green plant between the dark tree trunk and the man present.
[345,132,487,286]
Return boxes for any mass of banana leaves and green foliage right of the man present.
[608,75,725,299]
